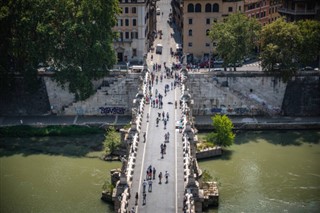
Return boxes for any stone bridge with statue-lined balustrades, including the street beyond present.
[109,1,206,212]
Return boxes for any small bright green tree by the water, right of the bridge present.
[206,115,235,147]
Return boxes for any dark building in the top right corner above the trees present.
[278,0,320,22]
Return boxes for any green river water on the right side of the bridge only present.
[199,131,320,213]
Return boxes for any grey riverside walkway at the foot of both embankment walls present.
[0,115,320,130]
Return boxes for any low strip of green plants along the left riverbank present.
[0,125,103,137]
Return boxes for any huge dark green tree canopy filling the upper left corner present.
[0,0,120,100]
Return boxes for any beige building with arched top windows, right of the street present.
[182,0,244,60]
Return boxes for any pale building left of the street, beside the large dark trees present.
[113,0,156,63]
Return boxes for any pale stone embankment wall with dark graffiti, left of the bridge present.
[44,72,140,115]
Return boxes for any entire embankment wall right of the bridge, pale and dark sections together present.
[186,72,320,116]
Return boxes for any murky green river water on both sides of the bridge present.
[0,131,320,213]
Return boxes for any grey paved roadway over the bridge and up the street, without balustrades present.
[128,0,184,213]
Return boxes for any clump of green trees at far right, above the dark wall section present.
[260,18,320,80]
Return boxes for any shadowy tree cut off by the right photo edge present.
[296,20,320,67]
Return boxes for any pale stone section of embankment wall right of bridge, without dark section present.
[187,73,286,115]
